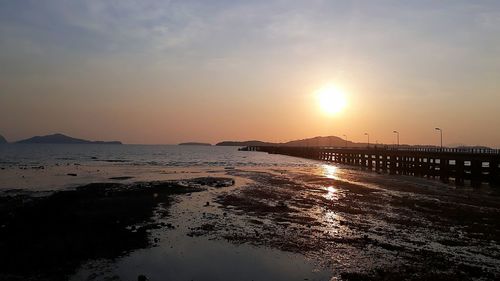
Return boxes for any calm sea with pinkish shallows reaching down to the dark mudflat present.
[0,144,319,190]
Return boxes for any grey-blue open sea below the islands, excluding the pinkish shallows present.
[0,144,311,168]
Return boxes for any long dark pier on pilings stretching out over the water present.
[245,146,500,186]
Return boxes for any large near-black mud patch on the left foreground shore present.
[0,178,233,280]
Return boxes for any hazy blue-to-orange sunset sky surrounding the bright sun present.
[0,0,500,144]
